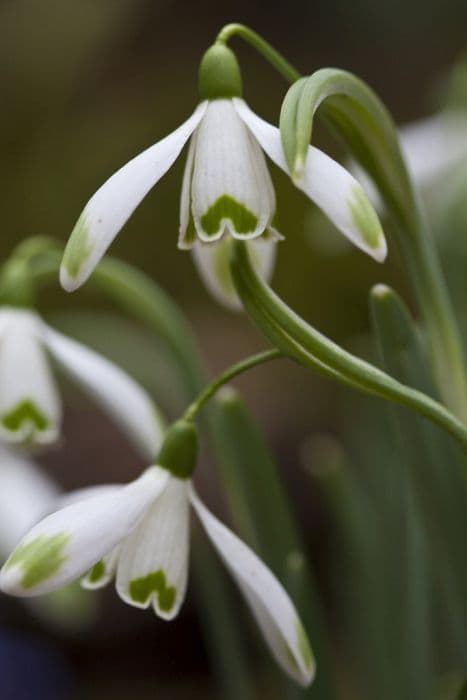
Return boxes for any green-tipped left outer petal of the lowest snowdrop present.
[0,467,168,596]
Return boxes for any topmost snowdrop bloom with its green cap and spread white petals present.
[60,45,386,302]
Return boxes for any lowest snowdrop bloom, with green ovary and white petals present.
[0,420,314,685]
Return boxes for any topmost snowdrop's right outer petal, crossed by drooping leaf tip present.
[234,98,387,262]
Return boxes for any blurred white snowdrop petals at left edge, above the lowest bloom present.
[0,307,163,458]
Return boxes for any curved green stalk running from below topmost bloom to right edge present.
[231,243,467,451]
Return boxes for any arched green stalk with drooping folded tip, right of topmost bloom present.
[280,69,467,420]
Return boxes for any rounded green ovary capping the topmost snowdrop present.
[199,44,242,100]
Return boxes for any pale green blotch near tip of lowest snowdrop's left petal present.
[5,532,70,589]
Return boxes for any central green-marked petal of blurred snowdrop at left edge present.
[0,310,62,444]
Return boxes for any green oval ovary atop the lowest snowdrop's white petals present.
[157,420,198,479]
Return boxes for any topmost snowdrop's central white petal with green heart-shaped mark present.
[191,100,275,242]
